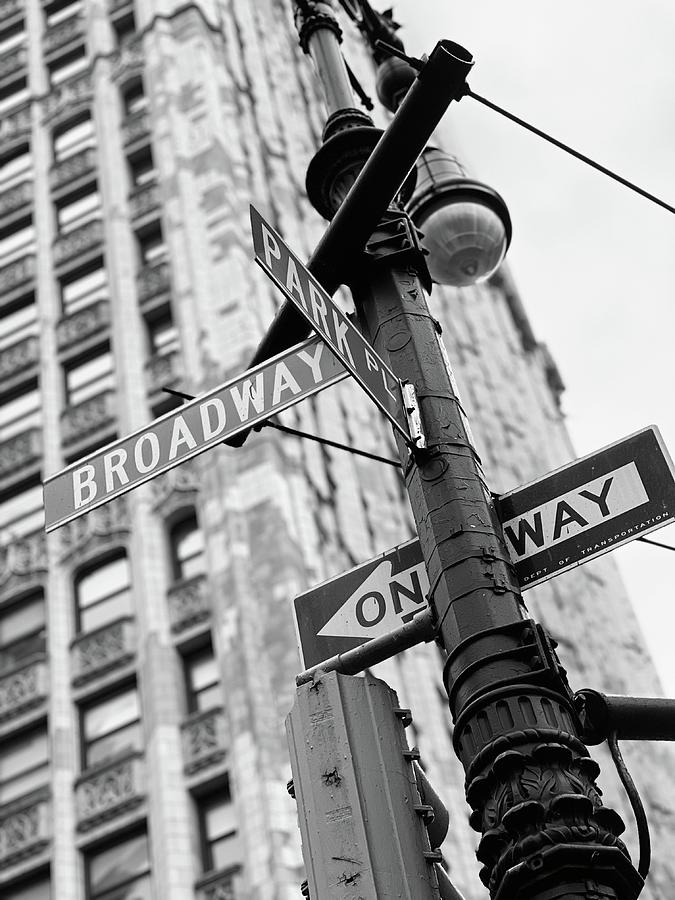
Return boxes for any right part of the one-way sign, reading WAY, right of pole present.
[497,425,675,589]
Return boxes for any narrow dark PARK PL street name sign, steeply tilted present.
[251,206,414,444]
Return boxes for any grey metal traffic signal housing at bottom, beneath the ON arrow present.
[286,672,459,900]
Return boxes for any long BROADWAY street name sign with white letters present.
[43,336,348,531]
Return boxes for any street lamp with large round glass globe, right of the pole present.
[407,147,511,287]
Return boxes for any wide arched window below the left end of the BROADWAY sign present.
[75,556,132,632]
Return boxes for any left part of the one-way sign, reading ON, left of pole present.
[293,539,429,669]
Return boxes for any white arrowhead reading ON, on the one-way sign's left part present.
[318,559,429,639]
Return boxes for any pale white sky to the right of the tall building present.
[394,0,675,697]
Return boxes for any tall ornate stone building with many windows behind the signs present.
[0,0,675,900]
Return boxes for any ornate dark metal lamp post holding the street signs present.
[286,0,643,900]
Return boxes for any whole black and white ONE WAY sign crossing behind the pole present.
[294,426,675,668]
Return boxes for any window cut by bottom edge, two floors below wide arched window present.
[87,833,152,900]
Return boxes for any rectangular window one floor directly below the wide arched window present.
[82,687,141,769]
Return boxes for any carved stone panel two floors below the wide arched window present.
[75,754,145,831]
